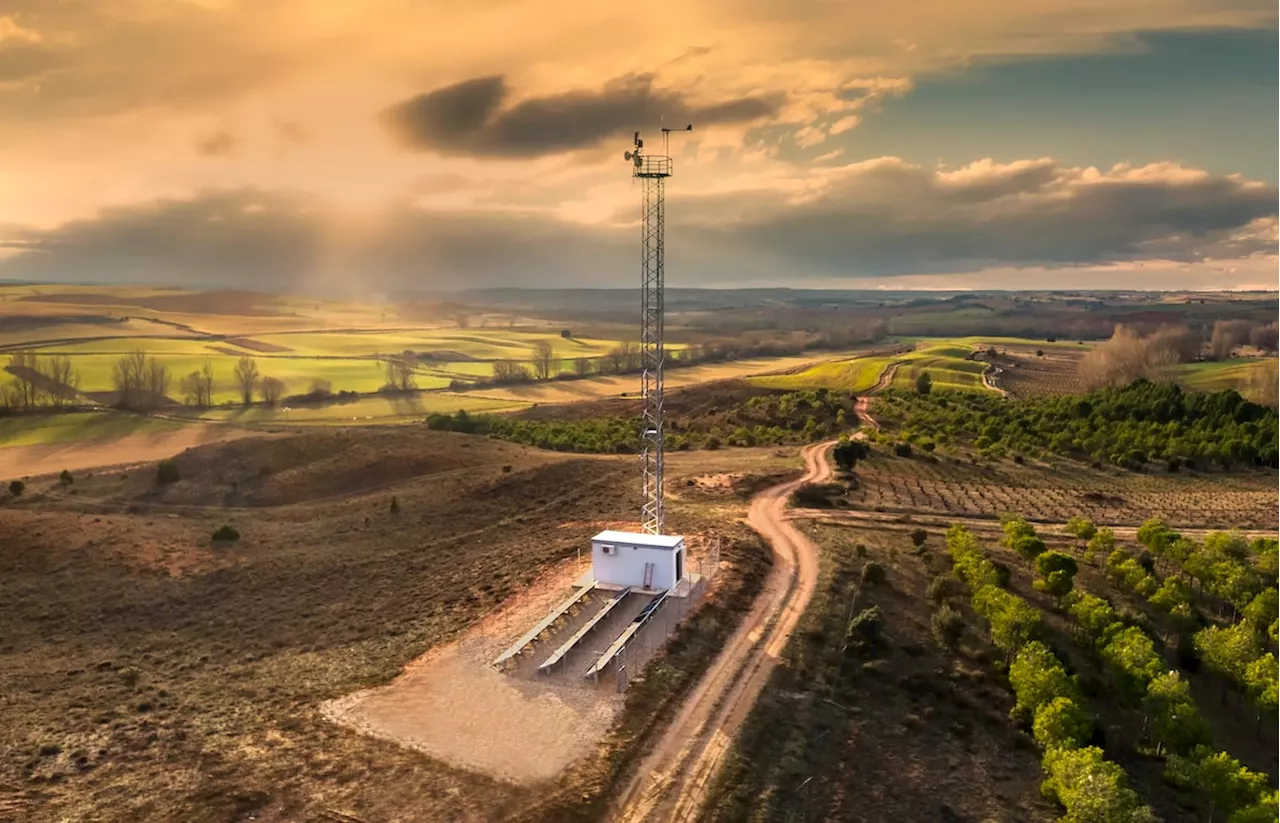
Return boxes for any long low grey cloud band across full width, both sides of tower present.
[0,159,1280,293]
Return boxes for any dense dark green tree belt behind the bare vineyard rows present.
[882,380,1280,471]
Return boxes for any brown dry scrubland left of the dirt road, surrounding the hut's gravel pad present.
[0,427,778,823]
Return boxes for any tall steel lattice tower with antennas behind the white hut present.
[625,125,694,534]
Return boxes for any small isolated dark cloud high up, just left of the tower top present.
[380,74,783,157]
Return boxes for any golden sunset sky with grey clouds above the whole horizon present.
[0,0,1280,297]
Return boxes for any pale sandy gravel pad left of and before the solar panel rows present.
[314,563,622,783]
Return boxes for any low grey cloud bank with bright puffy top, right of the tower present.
[686,157,1280,275]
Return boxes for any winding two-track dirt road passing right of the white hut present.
[611,389,897,823]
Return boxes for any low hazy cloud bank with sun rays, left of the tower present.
[0,189,635,293]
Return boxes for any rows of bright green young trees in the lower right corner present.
[1034,517,1280,823]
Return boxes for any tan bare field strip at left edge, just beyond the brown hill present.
[0,426,264,477]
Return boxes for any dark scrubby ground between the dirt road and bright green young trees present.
[701,523,1056,823]
